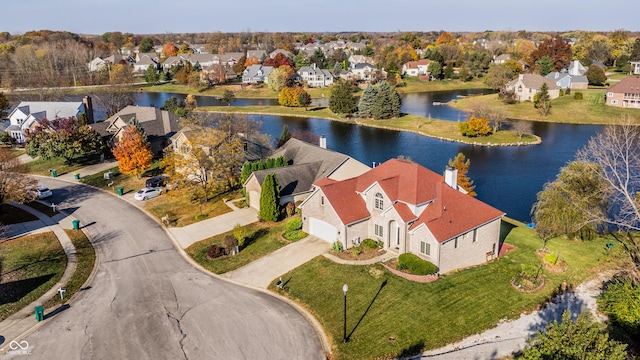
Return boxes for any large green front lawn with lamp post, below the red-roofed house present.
[270,218,620,359]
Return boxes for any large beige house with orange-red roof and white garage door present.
[300,159,504,273]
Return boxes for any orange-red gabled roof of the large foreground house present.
[314,159,504,242]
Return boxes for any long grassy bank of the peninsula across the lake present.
[198,106,539,144]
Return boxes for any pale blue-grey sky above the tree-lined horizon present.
[5,0,640,35]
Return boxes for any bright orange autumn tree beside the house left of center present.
[113,125,153,178]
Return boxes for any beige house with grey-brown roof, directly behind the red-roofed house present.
[244,137,370,210]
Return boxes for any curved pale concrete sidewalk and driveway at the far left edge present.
[0,203,77,354]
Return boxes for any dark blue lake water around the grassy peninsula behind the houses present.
[70,90,602,222]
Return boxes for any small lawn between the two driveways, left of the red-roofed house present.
[186,220,288,274]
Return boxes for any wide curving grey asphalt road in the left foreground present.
[15,179,324,359]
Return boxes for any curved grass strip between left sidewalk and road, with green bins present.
[45,230,96,307]
